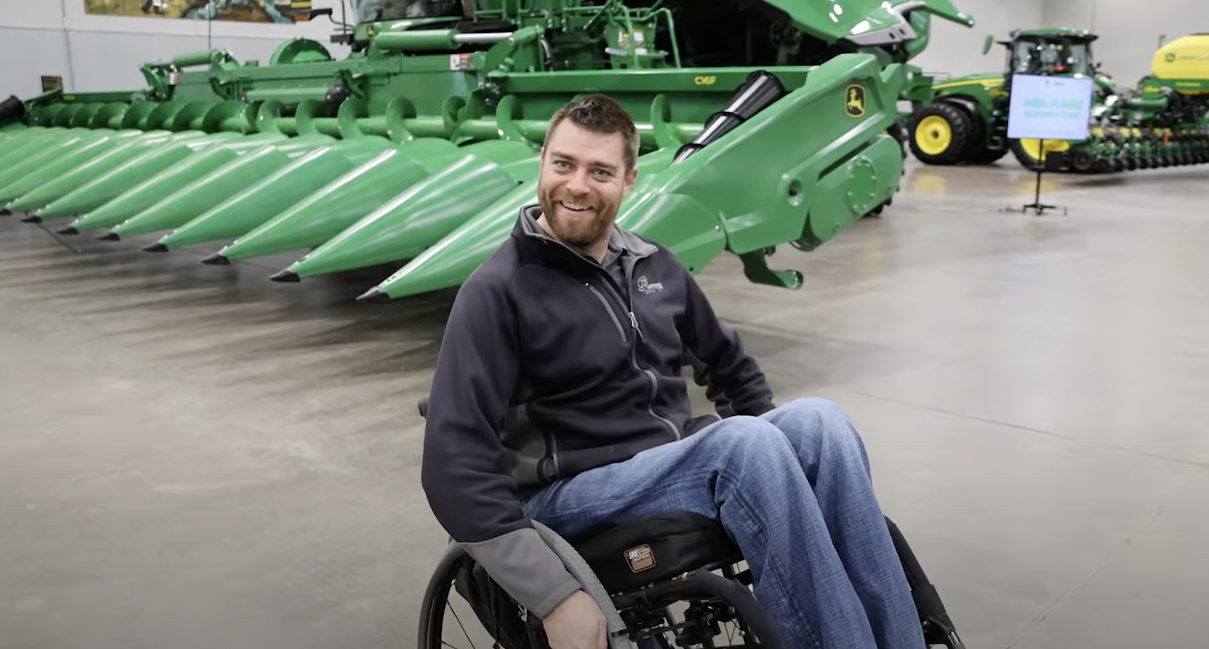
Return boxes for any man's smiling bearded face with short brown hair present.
[538,120,638,249]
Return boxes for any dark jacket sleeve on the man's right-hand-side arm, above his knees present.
[678,264,775,415]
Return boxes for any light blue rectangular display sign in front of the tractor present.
[1007,75,1093,141]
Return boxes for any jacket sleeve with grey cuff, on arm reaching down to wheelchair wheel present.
[421,269,580,619]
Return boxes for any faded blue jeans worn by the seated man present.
[525,399,925,649]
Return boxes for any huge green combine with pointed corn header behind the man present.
[0,0,973,300]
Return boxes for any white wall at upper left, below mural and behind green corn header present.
[0,0,351,98]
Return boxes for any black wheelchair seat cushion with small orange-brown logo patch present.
[567,512,742,595]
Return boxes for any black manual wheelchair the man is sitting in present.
[416,399,965,649]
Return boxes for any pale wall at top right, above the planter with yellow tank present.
[1045,0,1209,87]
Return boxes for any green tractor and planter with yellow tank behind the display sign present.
[909,29,1209,173]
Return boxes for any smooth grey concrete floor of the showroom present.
[0,158,1209,649]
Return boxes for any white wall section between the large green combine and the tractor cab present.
[913,0,1044,79]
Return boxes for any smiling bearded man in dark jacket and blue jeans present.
[422,95,924,649]
